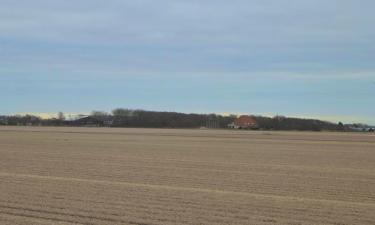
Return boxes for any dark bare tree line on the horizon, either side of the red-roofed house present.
[0,108,373,131]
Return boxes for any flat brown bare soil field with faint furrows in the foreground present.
[0,127,375,225]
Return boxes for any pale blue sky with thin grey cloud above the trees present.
[0,0,375,124]
